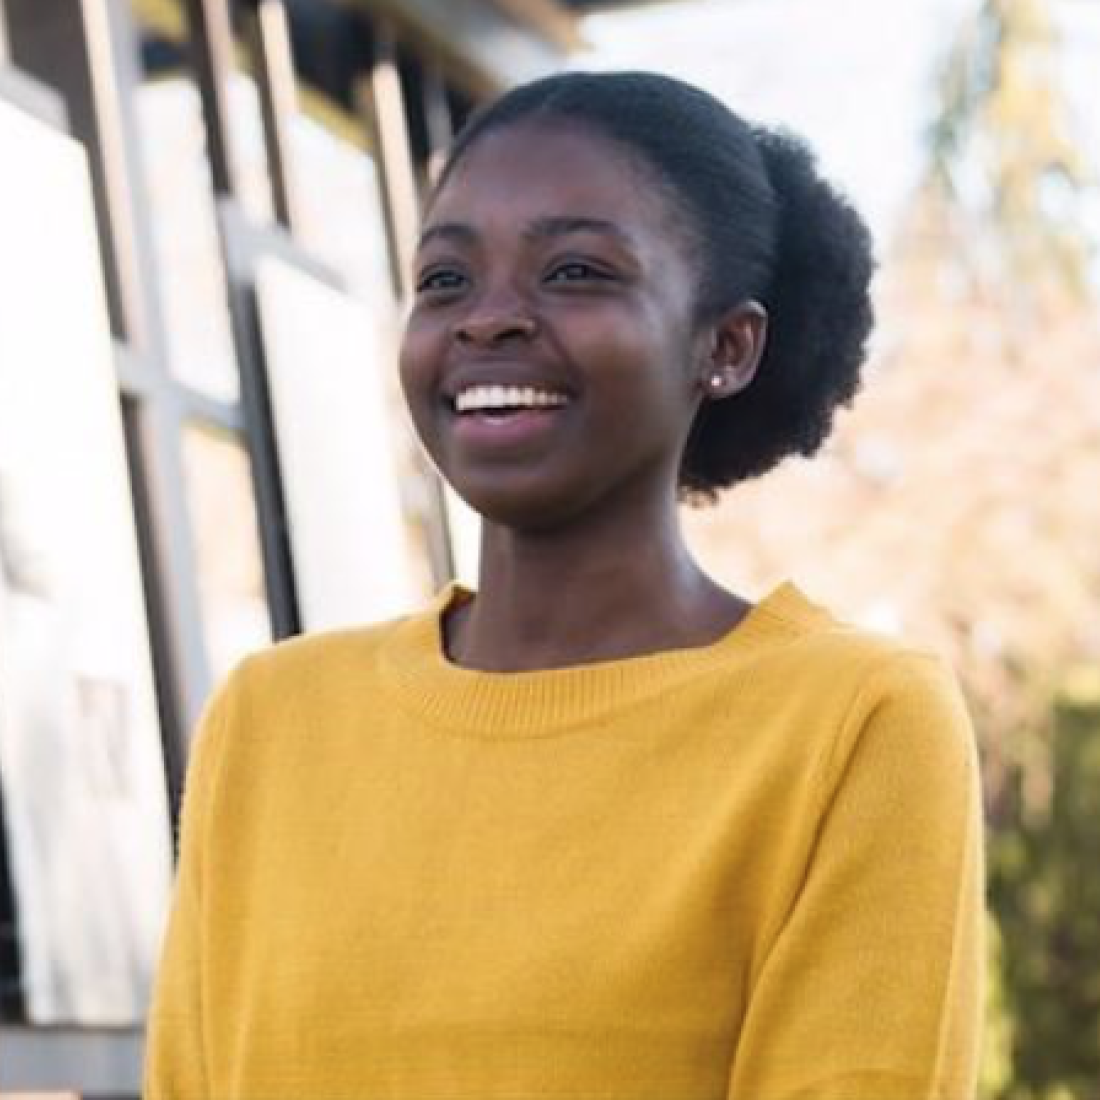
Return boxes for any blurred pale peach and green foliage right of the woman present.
[686,0,1100,1100]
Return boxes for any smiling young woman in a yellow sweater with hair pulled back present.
[147,74,983,1100]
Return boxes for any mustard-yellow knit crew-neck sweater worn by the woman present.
[146,584,983,1100]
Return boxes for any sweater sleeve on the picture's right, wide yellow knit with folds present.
[728,655,985,1100]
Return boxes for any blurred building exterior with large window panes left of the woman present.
[0,0,620,1097]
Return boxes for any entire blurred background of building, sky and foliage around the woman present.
[0,0,1100,1100]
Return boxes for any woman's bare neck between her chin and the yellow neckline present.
[444,501,749,672]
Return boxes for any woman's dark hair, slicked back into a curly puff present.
[436,73,875,504]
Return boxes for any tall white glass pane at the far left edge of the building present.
[0,101,172,1025]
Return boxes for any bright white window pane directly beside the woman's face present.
[256,259,427,630]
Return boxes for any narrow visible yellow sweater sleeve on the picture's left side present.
[143,673,228,1100]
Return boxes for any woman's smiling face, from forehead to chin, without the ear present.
[400,123,701,529]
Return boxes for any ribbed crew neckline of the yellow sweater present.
[380,581,832,739]
